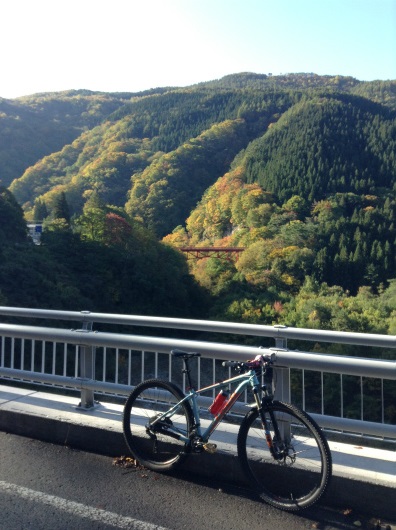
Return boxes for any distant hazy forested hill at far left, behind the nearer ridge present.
[0,88,175,190]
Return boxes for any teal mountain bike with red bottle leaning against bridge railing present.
[123,350,332,511]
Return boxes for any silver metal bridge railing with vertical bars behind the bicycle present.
[0,307,396,441]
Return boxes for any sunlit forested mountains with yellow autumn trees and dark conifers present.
[0,73,396,342]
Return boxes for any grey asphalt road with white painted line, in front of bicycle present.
[0,432,385,530]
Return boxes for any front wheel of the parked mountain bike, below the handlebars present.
[238,401,332,511]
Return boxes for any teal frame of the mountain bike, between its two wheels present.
[152,370,261,444]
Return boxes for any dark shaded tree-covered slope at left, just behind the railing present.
[0,188,206,317]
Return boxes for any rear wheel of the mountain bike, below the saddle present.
[123,379,193,471]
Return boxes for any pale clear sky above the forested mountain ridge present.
[0,0,396,99]
